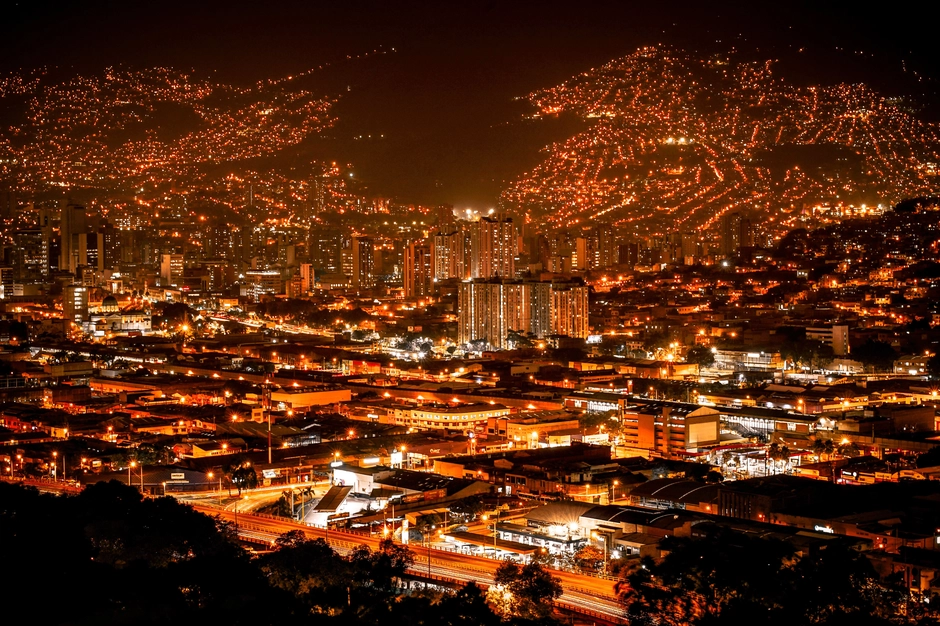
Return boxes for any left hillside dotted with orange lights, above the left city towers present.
[0,55,386,226]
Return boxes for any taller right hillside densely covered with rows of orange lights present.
[501,48,940,235]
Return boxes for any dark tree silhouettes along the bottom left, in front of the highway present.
[0,482,557,626]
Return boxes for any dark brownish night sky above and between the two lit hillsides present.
[0,1,938,207]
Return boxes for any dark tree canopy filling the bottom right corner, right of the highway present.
[618,529,938,626]
